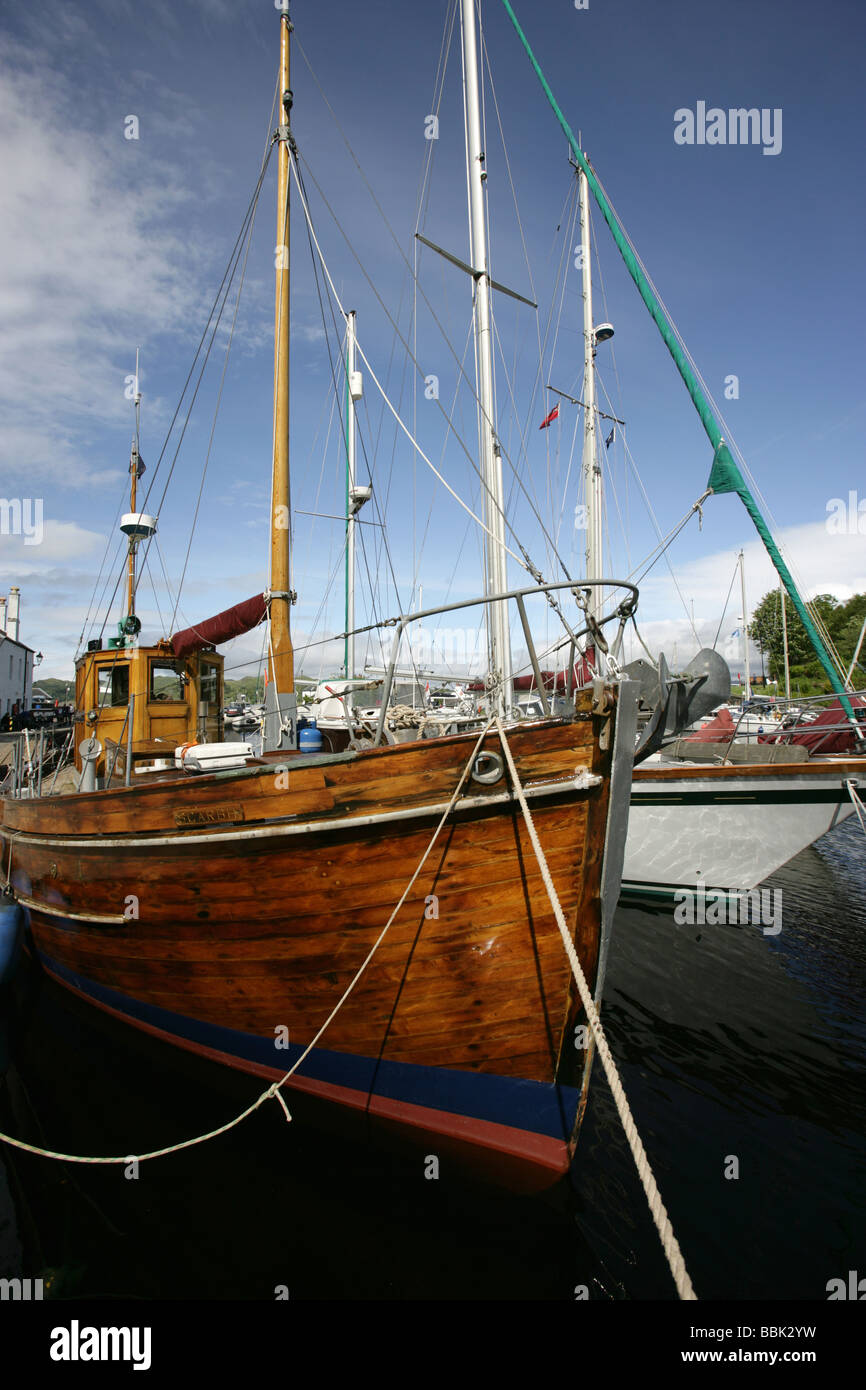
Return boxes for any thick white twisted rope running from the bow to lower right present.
[496,719,698,1300]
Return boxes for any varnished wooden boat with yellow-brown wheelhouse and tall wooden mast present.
[0,0,644,1187]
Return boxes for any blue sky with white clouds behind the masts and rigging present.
[0,0,866,689]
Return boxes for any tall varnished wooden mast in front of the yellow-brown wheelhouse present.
[264,13,296,751]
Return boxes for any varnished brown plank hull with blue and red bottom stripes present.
[3,696,636,1186]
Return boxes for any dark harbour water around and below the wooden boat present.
[0,819,866,1302]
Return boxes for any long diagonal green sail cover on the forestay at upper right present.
[502,0,860,734]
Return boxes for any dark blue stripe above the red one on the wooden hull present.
[39,951,580,1140]
